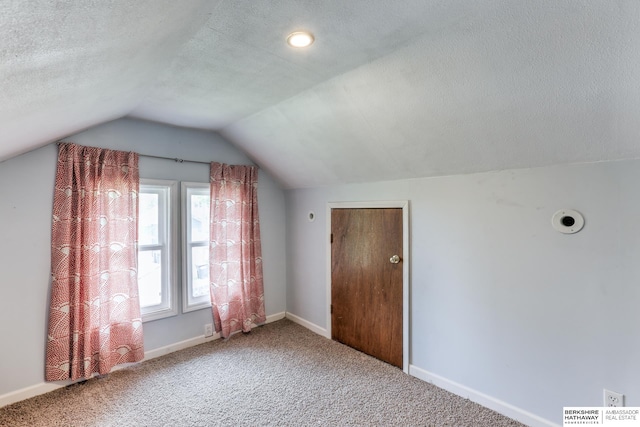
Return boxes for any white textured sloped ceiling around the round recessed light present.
[0,0,640,188]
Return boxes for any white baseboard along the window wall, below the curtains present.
[0,311,286,408]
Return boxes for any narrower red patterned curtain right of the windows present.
[209,163,266,338]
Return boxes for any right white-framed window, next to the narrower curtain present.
[182,182,211,312]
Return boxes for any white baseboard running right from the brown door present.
[409,365,559,427]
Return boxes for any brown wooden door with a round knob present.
[331,208,402,368]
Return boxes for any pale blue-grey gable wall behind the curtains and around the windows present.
[0,119,286,396]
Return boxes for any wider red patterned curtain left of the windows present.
[45,143,144,381]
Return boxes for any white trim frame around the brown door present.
[326,200,411,374]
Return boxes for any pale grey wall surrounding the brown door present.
[286,161,640,424]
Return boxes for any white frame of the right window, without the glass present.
[180,181,211,313]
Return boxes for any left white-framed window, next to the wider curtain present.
[138,179,178,321]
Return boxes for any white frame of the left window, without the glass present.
[136,178,178,323]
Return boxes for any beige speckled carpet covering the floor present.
[0,320,522,427]
